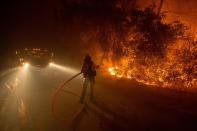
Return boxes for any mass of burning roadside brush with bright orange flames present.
[101,4,197,90]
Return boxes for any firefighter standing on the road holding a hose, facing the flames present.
[80,54,98,103]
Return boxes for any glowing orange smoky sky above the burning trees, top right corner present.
[131,0,197,31]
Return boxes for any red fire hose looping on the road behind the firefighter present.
[52,72,84,121]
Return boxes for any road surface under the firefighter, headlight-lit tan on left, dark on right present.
[0,68,197,131]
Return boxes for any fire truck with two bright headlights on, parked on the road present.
[16,48,54,68]
